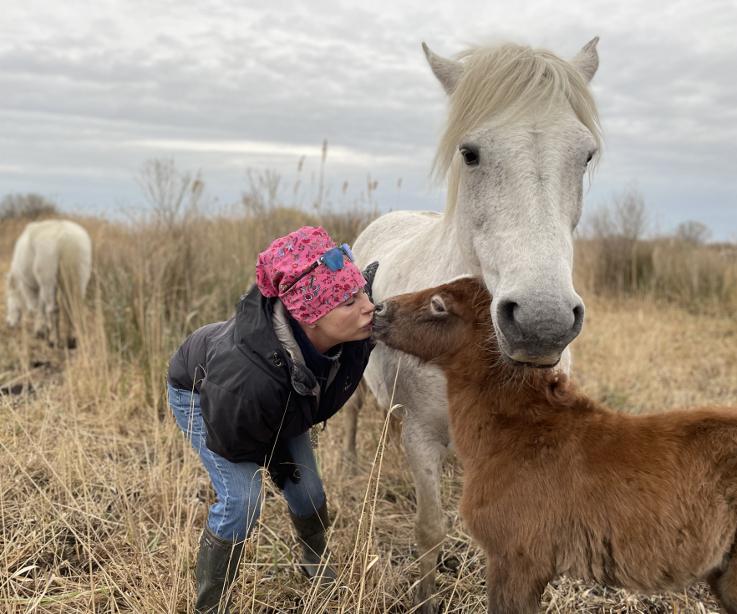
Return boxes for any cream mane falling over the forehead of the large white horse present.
[433,43,601,212]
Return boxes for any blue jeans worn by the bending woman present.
[167,383,325,541]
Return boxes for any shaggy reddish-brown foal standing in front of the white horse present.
[374,278,737,614]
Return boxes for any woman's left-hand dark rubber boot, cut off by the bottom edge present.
[195,526,245,614]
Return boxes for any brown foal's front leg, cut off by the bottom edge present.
[486,552,550,614]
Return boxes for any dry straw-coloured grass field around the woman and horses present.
[0,209,737,614]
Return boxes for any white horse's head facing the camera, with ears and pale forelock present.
[424,39,600,366]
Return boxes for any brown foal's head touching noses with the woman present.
[373,277,488,365]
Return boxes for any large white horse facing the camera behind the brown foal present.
[354,38,601,613]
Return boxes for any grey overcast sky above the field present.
[0,0,737,241]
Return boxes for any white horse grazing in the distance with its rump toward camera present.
[6,220,92,347]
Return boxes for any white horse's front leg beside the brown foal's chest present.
[402,411,447,614]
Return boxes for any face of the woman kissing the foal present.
[307,290,374,352]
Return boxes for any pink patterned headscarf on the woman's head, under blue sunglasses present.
[256,226,366,324]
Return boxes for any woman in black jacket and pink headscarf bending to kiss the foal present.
[168,226,378,612]
